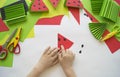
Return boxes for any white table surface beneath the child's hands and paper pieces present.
[0,11,120,77]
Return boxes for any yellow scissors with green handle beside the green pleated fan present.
[101,26,120,41]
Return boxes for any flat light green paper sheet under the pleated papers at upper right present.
[82,0,120,41]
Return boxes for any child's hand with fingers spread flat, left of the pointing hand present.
[36,47,59,71]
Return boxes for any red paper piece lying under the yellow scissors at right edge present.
[103,30,120,54]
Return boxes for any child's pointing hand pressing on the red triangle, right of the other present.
[59,46,75,70]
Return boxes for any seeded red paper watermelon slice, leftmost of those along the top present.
[31,0,48,12]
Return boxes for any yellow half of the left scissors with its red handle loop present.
[8,27,22,54]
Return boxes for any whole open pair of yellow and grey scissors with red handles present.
[0,27,22,60]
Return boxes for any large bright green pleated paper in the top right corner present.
[99,0,119,22]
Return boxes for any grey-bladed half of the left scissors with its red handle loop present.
[0,29,17,60]
